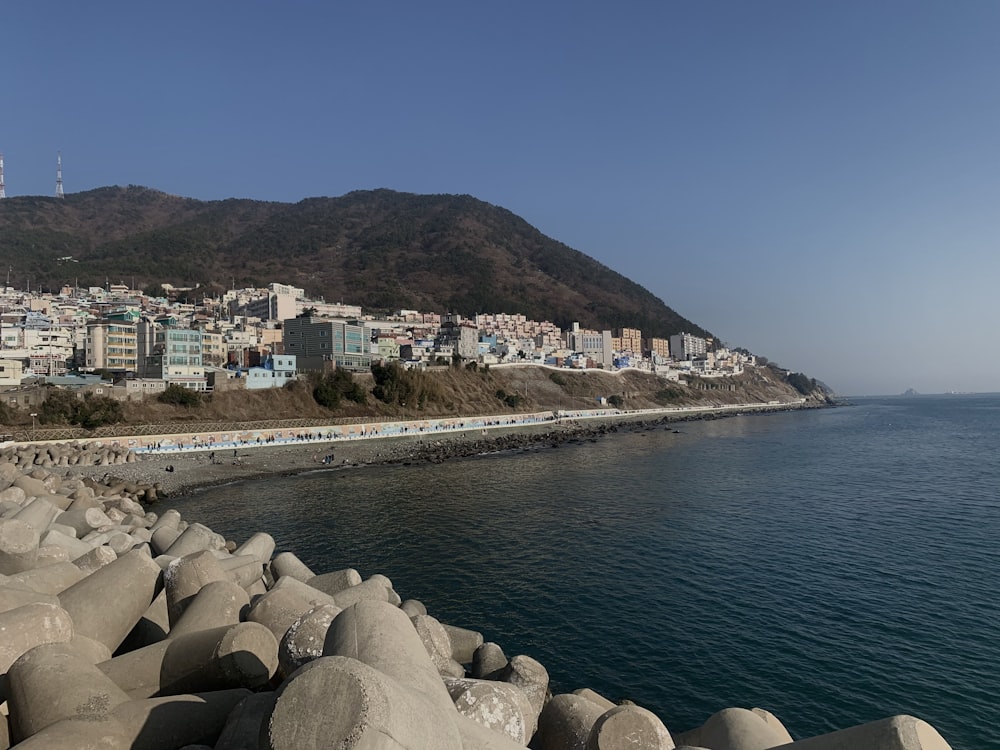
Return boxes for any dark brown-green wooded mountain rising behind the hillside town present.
[0,186,711,337]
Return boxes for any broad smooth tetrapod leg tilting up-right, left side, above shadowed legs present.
[59,551,161,653]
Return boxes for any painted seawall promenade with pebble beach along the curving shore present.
[27,401,815,497]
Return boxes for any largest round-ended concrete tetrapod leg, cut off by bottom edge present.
[260,656,463,750]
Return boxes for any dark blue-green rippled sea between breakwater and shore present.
[172,395,1000,750]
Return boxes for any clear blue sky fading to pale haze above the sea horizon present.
[0,0,1000,395]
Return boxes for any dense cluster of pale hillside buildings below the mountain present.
[0,283,752,403]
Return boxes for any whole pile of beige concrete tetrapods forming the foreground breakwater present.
[0,448,948,750]
